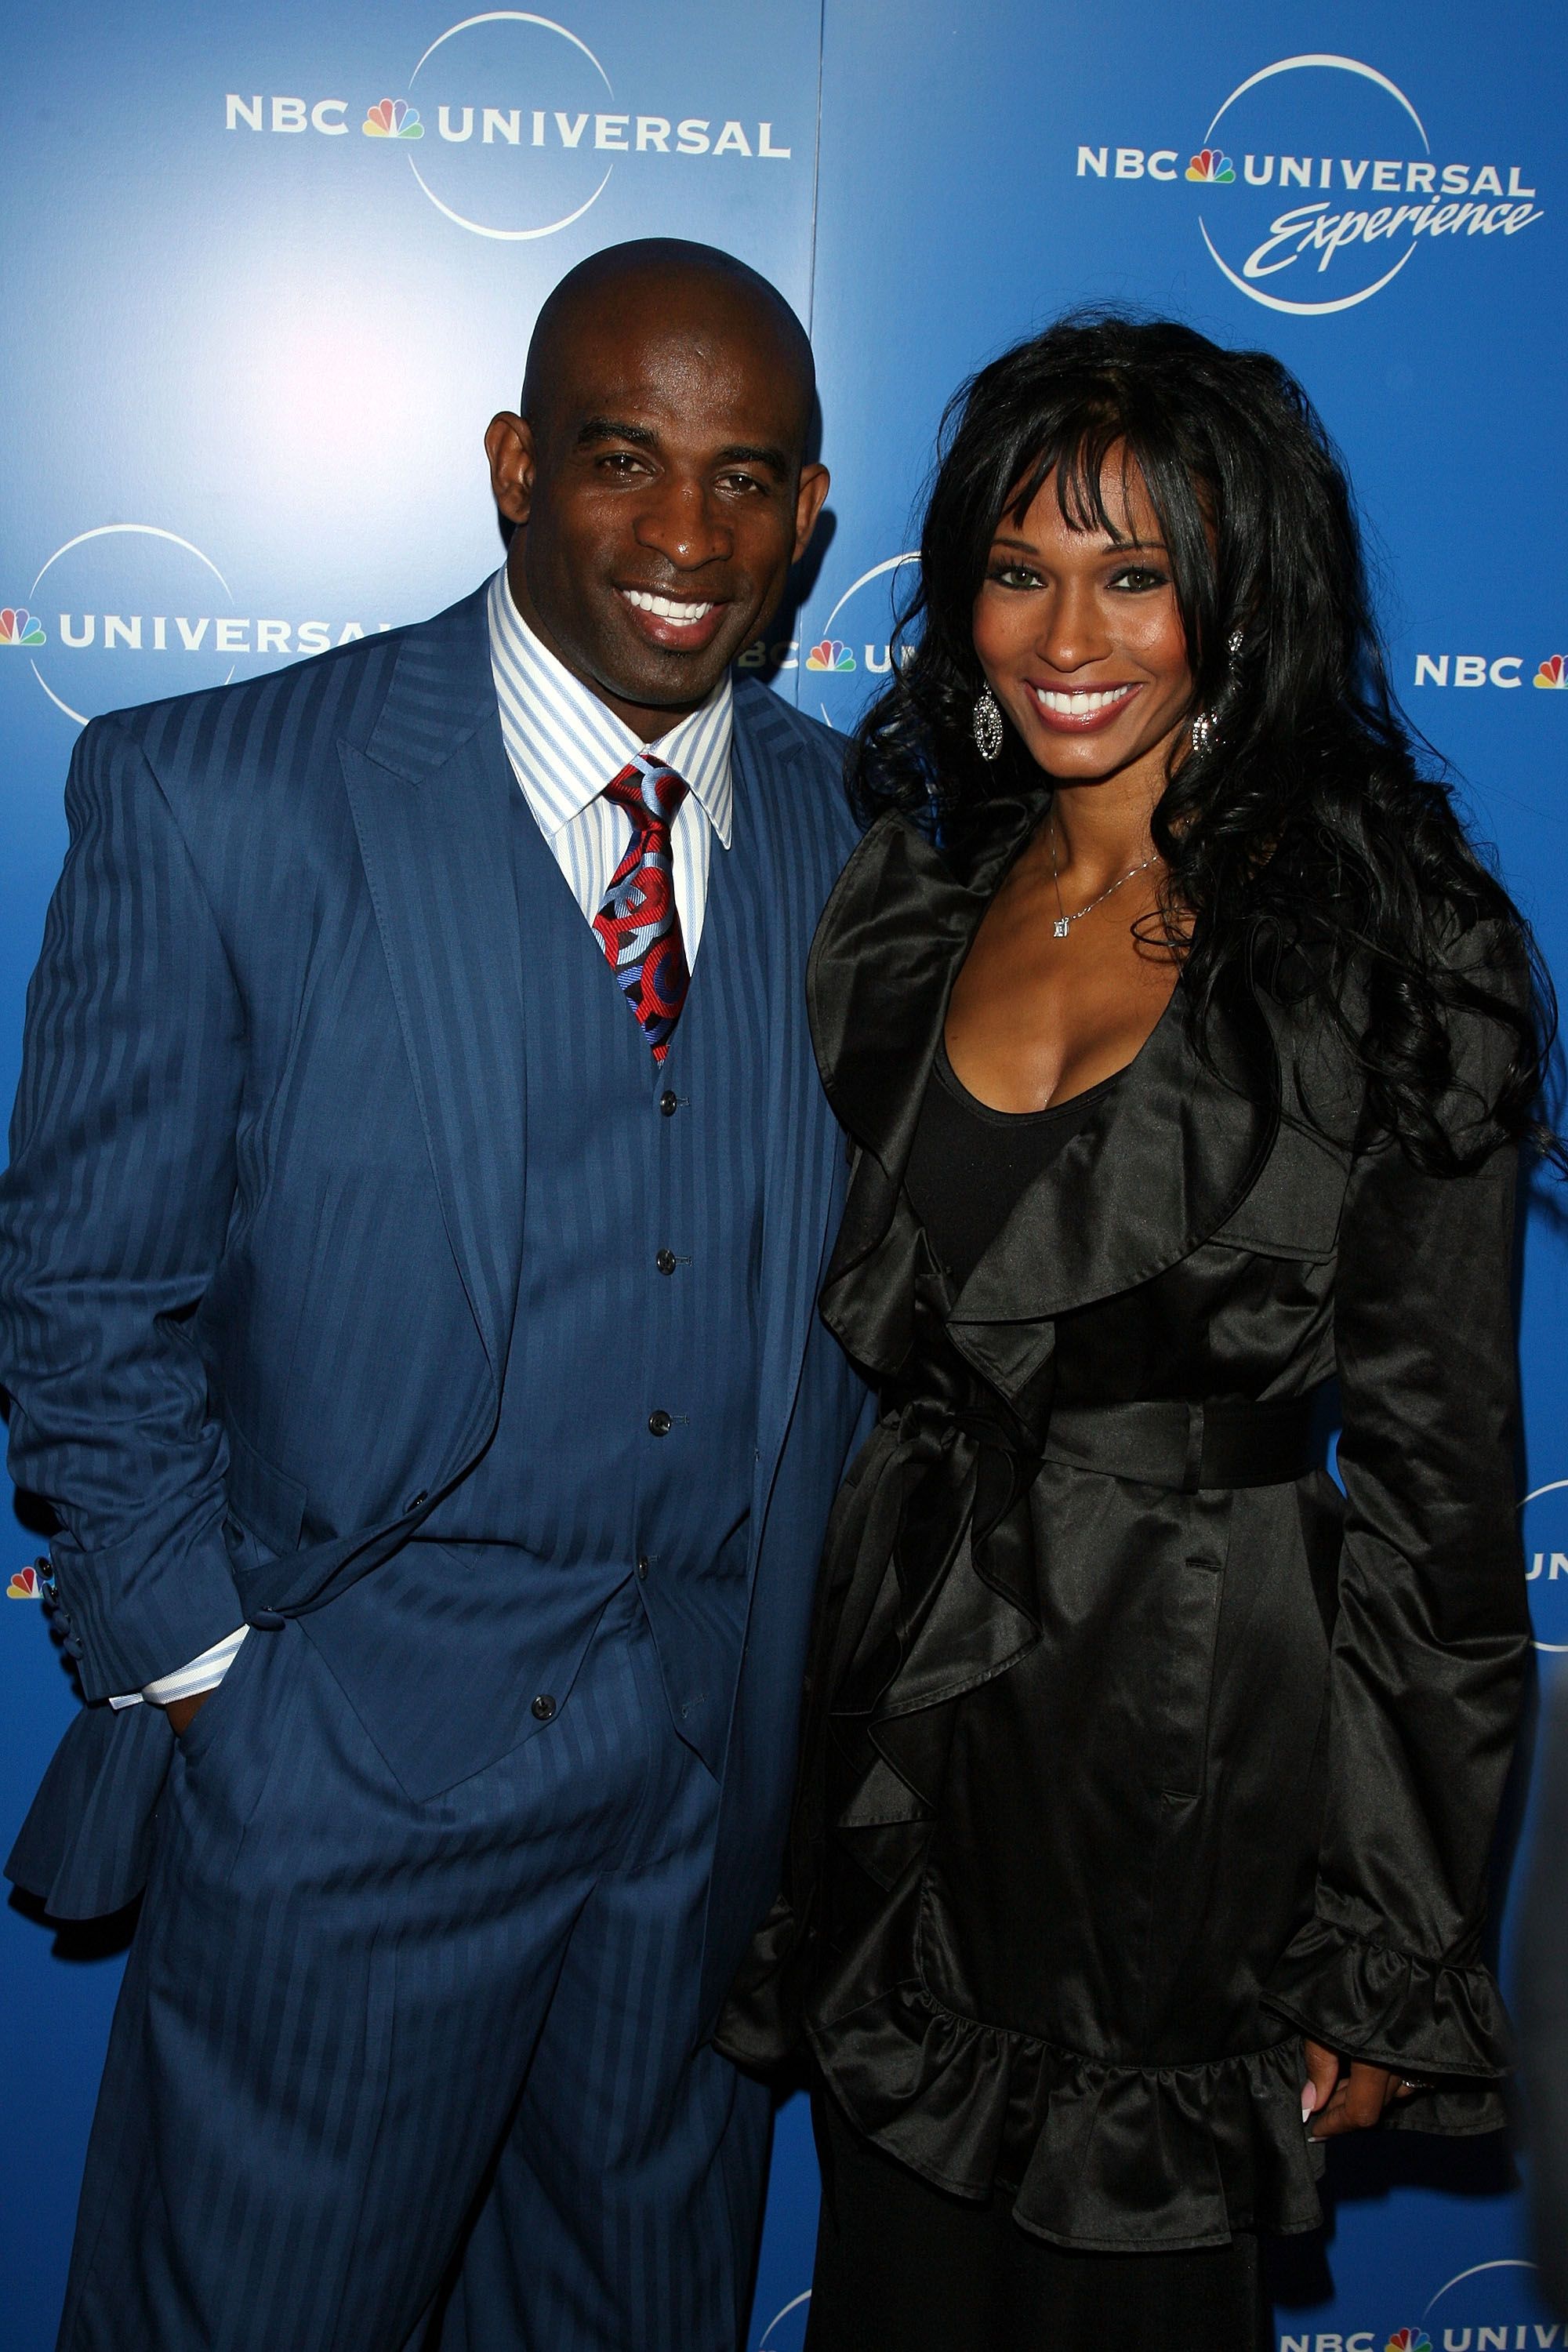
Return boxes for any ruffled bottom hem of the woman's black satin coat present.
[806,1983,1321,2251]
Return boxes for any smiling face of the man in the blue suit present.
[487,273,827,739]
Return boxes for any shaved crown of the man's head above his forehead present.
[522,238,815,463]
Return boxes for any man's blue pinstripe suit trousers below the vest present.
[59,1583,769,2352]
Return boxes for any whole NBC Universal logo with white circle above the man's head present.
[223,9,792,240]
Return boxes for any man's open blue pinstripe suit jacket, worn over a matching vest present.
[0,593,862,1999]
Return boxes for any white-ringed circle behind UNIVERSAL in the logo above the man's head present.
[404,7,611,242]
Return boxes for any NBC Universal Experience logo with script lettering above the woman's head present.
[1076,54,1542,318]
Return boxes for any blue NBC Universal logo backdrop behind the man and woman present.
[0,0,1568,2352]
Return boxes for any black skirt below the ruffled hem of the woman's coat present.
[806,2091,1272,2352]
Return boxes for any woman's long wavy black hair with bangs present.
[848,313,1561,1171]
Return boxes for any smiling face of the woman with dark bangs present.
[973,449,1192,783]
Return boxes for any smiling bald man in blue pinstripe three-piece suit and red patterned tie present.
[0,240,862,2352]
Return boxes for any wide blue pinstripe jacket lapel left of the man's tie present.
[339,590,524,1402]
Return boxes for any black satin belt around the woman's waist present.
[1039,1383,1326,1494]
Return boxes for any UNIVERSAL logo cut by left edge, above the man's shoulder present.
[0,522,393,727]
